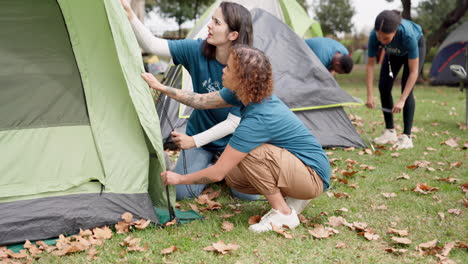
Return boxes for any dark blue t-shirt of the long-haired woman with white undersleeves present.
[168,39,240,151]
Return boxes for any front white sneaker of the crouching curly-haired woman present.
[249,208,299,233]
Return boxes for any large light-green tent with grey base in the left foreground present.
[0,0,166,245]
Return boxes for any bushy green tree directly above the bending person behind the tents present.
[315,0,356,36]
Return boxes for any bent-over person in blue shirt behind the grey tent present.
[305,37,354,75]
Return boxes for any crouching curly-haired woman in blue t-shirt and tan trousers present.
[142,45,330,232]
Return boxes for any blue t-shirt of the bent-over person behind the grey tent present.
[305,37,349,70]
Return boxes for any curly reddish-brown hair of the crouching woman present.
[230,44,273,105]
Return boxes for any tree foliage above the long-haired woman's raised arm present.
[146,0,214,37]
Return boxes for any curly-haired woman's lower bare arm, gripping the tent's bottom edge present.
[161,145,248,185]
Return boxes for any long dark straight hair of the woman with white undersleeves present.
[201,2,253,60]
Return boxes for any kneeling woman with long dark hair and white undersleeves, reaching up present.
[121,0,258,200]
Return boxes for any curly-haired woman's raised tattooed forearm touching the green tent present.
[141,73,232,109]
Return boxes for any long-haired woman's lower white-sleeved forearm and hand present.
[171,114,240,149]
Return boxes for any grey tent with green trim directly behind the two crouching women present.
[157,1,365,147]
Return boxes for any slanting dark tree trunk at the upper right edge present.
[420,0,468,78]
